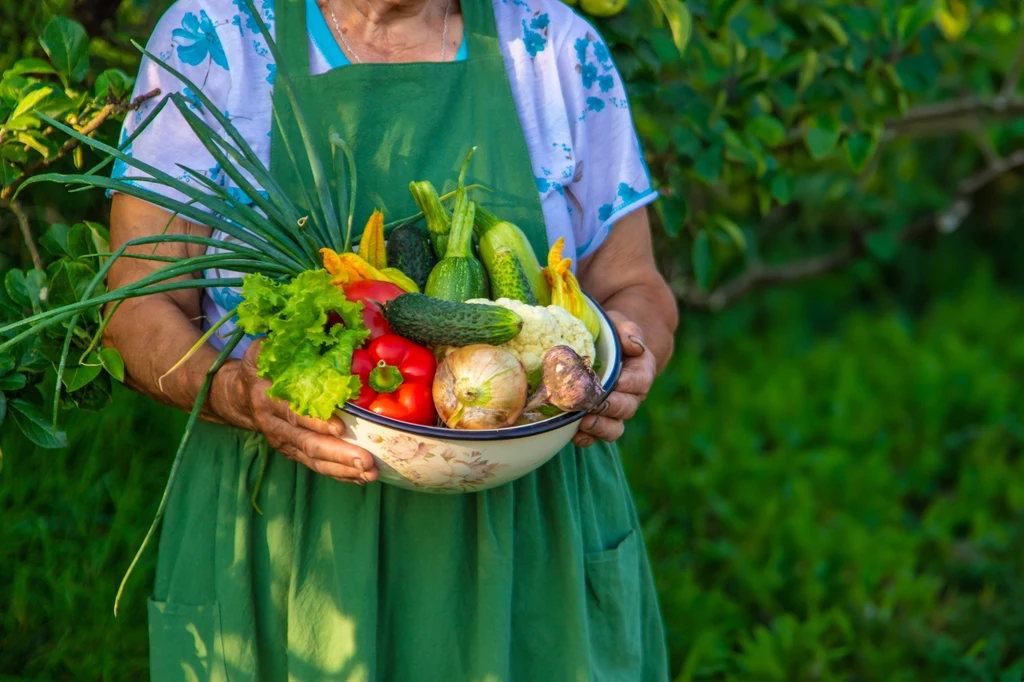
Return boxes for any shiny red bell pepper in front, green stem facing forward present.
[351,334,437,426]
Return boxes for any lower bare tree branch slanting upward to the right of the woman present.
[675,150,1024,310]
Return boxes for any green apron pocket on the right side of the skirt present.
[584,530,642,682]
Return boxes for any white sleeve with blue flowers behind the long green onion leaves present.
[111,0,243,208]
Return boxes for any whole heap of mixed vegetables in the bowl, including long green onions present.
[0,0,600,613]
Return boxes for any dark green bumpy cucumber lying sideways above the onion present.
[384,294,522,346]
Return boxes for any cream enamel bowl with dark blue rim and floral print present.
[338,299,622,494]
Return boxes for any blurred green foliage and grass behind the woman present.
[0,0,1024,682]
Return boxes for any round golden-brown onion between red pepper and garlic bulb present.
[434,344,527,429]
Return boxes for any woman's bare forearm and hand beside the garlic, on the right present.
[573,210,679,447]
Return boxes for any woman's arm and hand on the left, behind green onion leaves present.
[103,195,377,483]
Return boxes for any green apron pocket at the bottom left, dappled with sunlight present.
[148,597,227,682]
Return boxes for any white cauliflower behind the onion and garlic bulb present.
[466,298,597,374]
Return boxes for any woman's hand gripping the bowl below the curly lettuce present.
[241,341,377,485]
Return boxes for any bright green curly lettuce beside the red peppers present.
[238,270,370,419]
